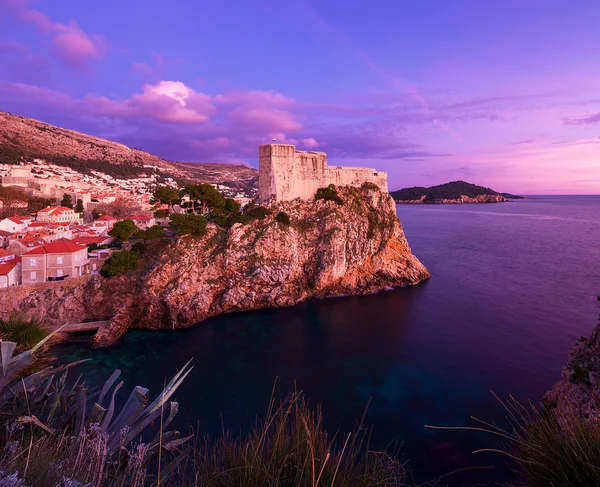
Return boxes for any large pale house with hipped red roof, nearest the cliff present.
[22,239,90,284]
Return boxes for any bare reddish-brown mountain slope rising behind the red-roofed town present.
[0,111,258,190]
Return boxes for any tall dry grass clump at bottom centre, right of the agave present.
[174,393,406,487]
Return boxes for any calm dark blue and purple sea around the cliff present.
[52,197,600,486]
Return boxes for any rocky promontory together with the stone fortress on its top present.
[0,144,429,346]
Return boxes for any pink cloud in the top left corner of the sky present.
[0,0,107,70]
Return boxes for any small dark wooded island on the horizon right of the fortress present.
[390,181,523,204]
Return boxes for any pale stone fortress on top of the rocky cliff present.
[258,144,388,202]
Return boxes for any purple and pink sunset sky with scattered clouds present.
[0,0,600,194]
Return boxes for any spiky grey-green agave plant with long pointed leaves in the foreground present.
[0,329,193,484]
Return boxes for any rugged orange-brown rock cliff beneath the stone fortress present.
[4,188,429,346]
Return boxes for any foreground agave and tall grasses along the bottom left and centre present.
[0,337,406,487]
